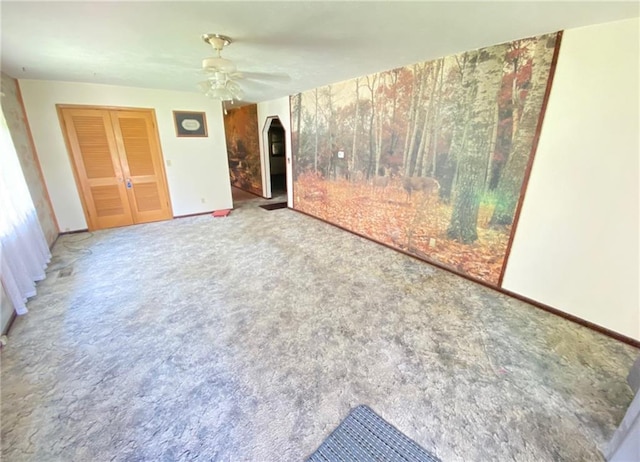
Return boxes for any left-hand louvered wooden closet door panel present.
[61,108,133,230]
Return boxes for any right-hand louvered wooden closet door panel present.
[111,111,173,223]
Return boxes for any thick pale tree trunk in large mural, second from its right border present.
[447,45,507,244]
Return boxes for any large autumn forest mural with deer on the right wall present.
[291,34,559,285]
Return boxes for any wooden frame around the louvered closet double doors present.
[56,104,174,231]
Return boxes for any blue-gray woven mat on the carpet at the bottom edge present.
[307,406,440,462]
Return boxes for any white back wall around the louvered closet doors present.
[19,80,232,231]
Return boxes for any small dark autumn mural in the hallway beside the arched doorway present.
[224,104,262,196]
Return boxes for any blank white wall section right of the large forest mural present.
[503,19,640,340]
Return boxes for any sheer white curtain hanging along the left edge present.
[0,107,51,314]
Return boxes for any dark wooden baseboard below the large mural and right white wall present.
[289,207,640,349]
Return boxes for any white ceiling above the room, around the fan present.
[0,1,640,102]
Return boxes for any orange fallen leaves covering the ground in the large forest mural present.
[294,174,510,285]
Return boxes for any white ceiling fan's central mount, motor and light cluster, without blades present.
[199,34,244,104]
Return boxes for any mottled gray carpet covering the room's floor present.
[1,199,639,461]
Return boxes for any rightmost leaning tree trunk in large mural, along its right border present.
[489,36,555,226]
